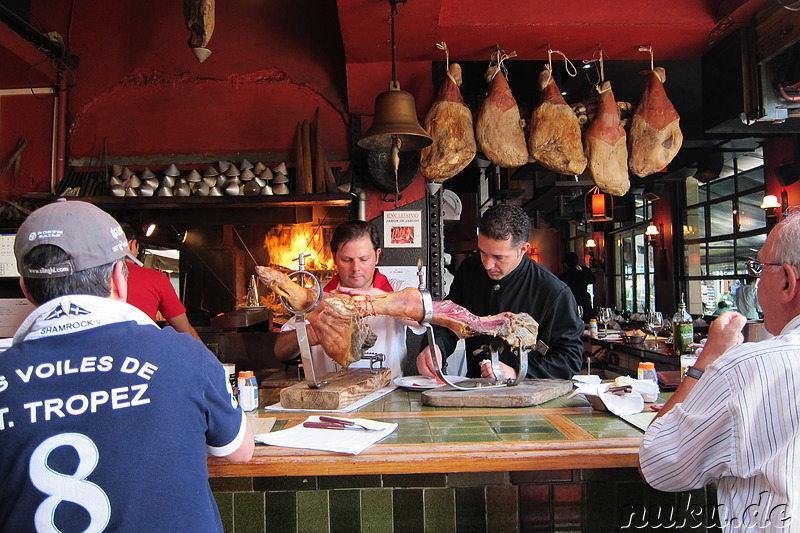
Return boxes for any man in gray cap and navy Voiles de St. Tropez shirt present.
[0,201,254,531]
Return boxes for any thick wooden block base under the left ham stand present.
[281,368,392,411]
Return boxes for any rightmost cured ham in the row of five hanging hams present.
[628,67,683,178]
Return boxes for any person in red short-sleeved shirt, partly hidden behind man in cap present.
[120,222,202,340]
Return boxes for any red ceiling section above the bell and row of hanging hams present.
[338,0,772,114]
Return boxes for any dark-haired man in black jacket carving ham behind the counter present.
[417,204,583,379]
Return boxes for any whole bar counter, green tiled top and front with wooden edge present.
[209,389,714,533]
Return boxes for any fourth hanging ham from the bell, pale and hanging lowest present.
[584,81,631,196]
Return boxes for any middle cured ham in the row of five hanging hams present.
[528,69,586,175]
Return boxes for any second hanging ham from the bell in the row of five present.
[475,65,528,168]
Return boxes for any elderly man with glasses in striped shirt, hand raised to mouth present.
[639,208,800,531]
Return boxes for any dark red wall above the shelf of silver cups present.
[32,0,349,162]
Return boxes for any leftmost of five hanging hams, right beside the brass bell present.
[419,63,476,182]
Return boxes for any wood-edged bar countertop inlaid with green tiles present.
[209,382,643,477]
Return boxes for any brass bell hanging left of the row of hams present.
[358,83,433,152]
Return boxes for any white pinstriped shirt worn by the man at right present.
[639,316,800,532]
